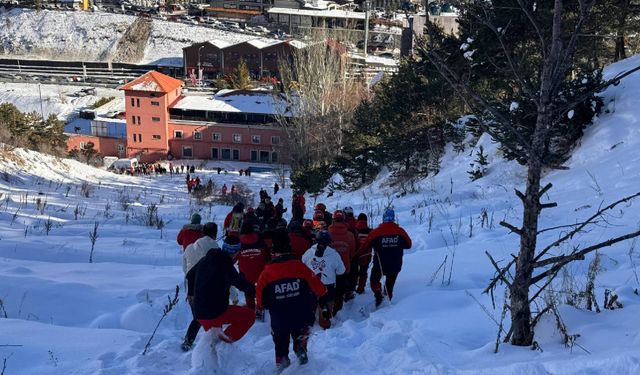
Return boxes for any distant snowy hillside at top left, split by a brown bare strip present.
[0,8,255,66]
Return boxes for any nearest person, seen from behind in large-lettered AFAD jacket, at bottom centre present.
[256,229,327,371]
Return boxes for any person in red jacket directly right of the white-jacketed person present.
[329,210,356,315]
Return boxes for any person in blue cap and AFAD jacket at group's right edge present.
[363,209,411,307]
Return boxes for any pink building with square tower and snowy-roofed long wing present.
[114,71,286,163]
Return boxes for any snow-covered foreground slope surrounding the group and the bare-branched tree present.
[0,56,640,375]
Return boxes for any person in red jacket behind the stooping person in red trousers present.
[236,223,269,314]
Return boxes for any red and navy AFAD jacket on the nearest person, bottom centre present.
[256,254,327,331]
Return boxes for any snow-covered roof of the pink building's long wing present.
[172,90,286,115]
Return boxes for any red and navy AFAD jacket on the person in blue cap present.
[364,223,411,275]
